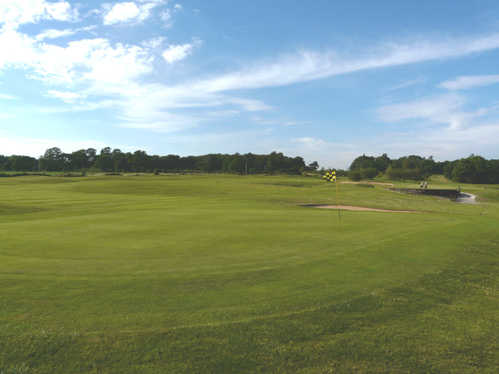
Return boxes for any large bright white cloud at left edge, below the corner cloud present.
[0,30,153,85]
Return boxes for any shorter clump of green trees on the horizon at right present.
[348,153,499,183]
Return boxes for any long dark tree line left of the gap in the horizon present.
[0,147,310,174]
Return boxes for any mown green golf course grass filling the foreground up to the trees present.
[0,175,499,374]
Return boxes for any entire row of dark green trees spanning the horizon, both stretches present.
[0,147,499,184]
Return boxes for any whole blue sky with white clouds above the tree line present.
[0,0,499,167]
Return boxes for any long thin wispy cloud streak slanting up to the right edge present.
[188,34,499,92]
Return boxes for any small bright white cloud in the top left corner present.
[0,0,78,30]
